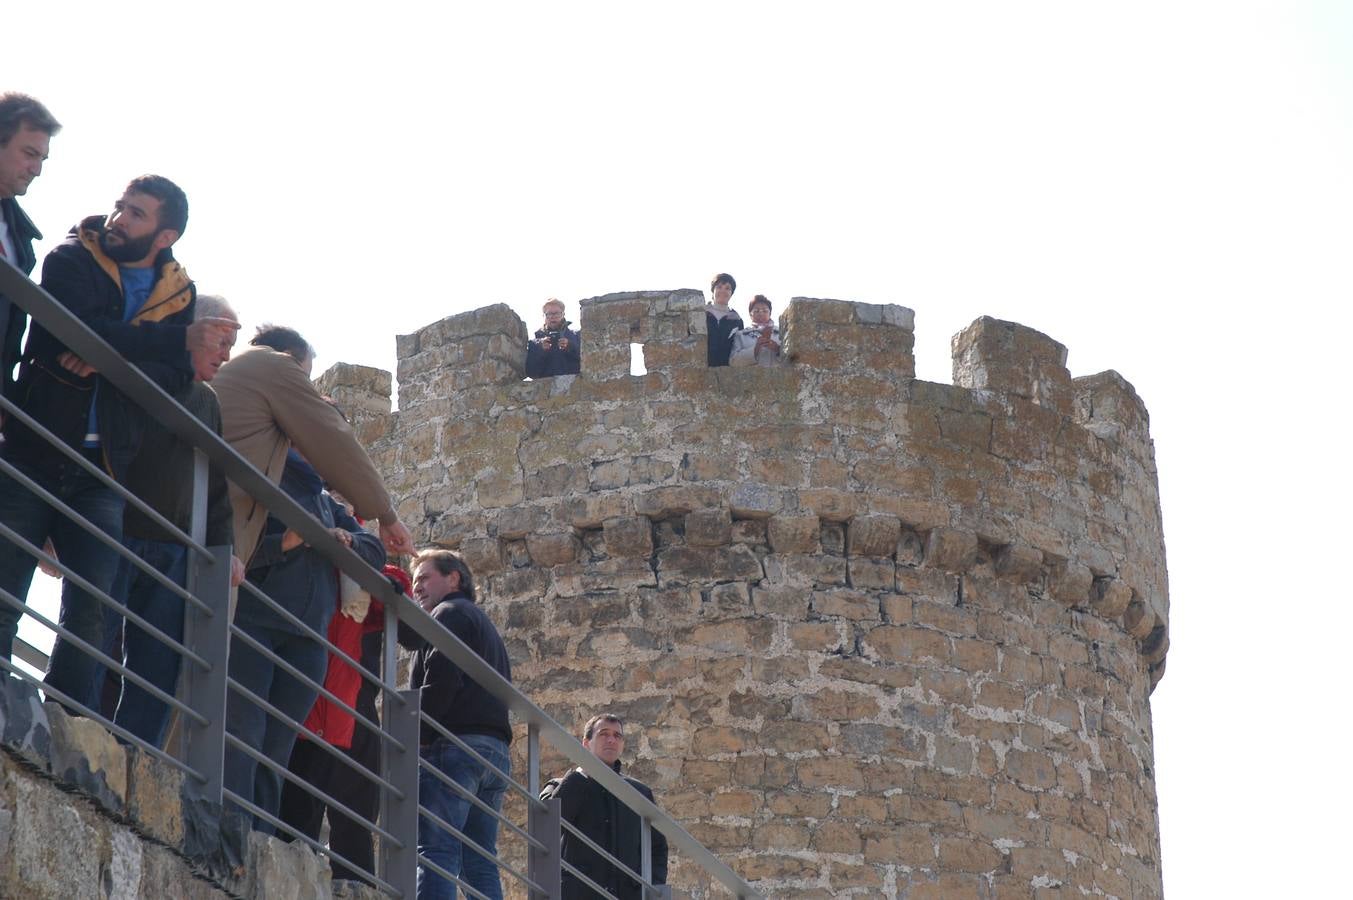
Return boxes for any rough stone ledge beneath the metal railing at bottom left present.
[0,675,340,900]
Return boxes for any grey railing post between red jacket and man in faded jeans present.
[380,684,418,897]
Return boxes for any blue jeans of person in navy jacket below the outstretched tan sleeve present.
[223,620,329,834]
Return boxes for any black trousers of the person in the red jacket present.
[277,723,380,880]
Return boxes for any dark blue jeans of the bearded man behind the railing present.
[0,451,124,701]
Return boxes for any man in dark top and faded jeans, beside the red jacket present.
[409,549,511,900]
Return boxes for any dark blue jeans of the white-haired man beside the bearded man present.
[95,537,188,748]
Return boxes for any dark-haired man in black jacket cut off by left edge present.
[0,92,61,400]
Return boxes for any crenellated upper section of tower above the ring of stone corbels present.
[376,290,1169,652]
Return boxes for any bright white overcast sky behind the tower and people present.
[0,0,1353,897]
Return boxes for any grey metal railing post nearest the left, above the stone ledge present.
[180,547,230,803]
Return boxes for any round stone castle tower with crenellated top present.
[340,291,1168,900]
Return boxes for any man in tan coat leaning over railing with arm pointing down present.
[211,325,414,563]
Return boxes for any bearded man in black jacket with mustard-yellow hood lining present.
[0,175,239,702]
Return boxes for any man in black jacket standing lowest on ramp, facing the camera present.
[540,713,667,900]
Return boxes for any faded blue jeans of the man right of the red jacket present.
[418,735,511,900]
